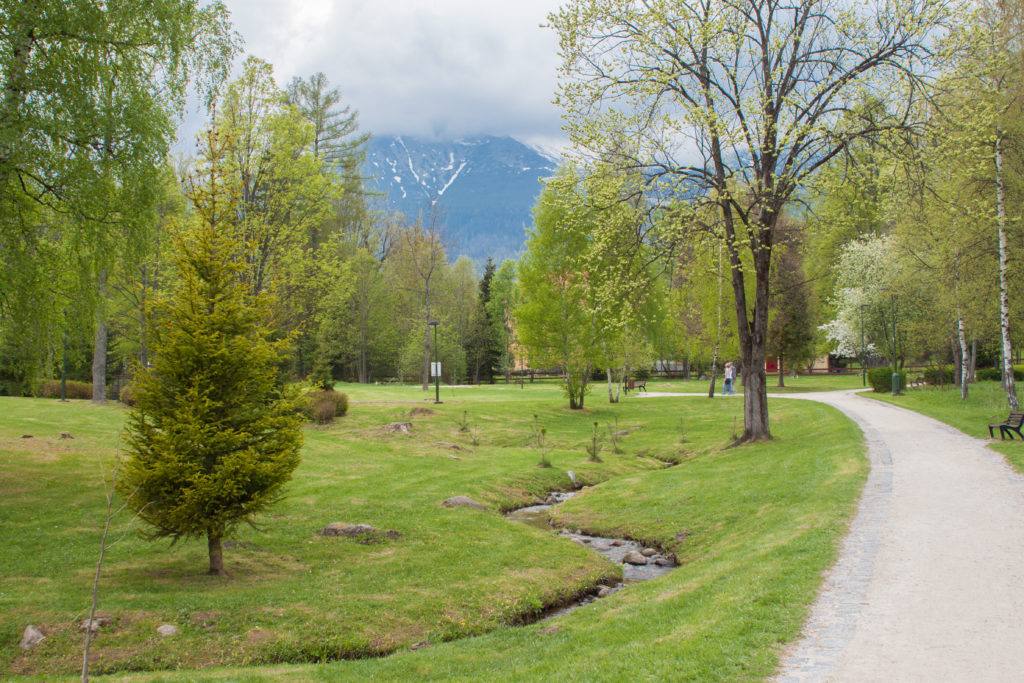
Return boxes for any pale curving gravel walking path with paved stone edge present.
[774,392,1024,683]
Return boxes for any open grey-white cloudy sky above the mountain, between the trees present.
[193,0,560,147]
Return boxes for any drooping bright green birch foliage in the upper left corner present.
[0,0,236,382]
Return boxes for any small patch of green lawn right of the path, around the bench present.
[864,382,1024,472]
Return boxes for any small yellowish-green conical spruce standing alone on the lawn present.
[119,125,302,574]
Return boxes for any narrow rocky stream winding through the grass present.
[506,492,676,618]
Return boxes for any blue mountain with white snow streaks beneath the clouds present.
[365,135,558,265]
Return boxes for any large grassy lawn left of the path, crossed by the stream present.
[0,378,867,681]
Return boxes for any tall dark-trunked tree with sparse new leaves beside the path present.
[550,0,950,441]
